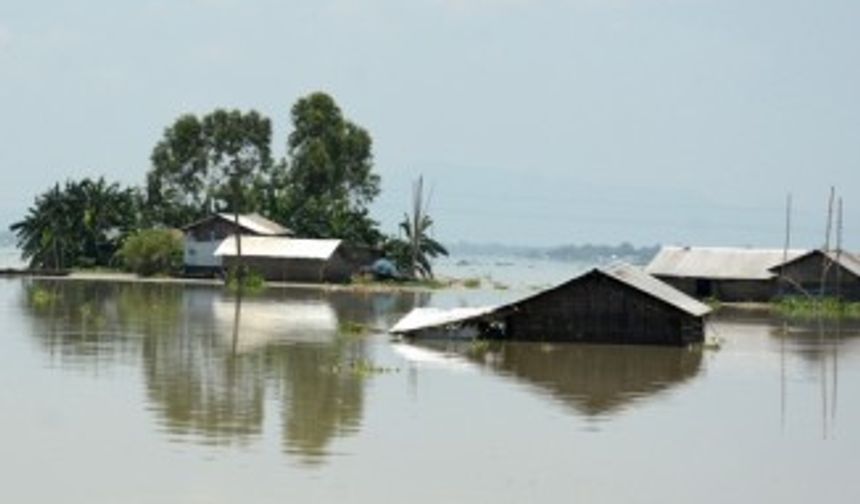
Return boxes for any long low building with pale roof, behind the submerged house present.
[645,246,807,302]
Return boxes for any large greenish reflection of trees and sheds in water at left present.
[22,281,427,464]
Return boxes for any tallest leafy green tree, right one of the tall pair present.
[269,92,382,245]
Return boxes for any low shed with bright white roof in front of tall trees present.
[215,236,355,283]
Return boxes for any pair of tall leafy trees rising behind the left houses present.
[146,93,382,245]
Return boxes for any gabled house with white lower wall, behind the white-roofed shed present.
[182,213,292,274]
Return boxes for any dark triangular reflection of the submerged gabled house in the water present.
[412,341,702,418]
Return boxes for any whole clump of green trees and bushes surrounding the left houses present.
[10,92,446,275]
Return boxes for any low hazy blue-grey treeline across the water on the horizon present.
[448,242,660,264]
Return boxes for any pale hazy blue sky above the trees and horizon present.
[0,0,860,248]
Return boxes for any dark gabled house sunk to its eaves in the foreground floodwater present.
[391,264,711,345]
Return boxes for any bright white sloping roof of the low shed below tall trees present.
[215,236,341,260]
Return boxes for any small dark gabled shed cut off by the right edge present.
[770,250,860,301]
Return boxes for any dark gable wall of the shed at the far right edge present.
[781,254,860,301]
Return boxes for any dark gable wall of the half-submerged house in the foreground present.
[504,274,704,345]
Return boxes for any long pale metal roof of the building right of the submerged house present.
[645,247,807,280]
